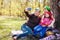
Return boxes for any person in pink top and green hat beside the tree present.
[34,6,54,38]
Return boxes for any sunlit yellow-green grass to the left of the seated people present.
[0,16,25,40]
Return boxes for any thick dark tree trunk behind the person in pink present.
[50,0,60,30]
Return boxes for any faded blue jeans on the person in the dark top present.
[17,24,32,39]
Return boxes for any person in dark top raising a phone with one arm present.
[17,8,41,39]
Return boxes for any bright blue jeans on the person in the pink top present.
[34,25,47,38]
